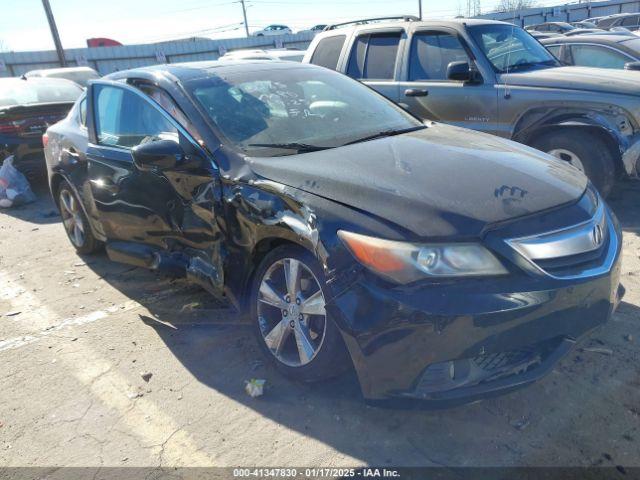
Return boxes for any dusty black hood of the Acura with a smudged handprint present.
[248,124,587,238]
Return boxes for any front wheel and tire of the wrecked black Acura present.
[251,245,349,382]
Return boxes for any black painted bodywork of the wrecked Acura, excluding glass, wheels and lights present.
[46,62,621,405]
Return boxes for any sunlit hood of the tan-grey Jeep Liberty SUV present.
[500,67,640,95]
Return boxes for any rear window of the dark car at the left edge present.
[0,78,82,107]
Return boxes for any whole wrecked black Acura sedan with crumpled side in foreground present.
[45,62,622,405]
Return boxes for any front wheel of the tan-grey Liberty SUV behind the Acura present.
[531,130,617,197]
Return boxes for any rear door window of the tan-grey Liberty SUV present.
[347,32,401,80]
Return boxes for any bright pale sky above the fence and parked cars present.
[0,0,556,51]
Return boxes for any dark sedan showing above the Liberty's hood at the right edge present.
[540,35,640,70]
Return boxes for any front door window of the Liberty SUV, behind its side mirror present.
[409,32,470,81]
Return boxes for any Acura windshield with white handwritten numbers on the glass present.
[187,64,425,157]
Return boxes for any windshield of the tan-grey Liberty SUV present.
[469,24,559,73]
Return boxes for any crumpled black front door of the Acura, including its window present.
[87,81,222,256]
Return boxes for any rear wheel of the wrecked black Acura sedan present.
[58,182,100,254]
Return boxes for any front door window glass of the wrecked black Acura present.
[94,86,178,148]
